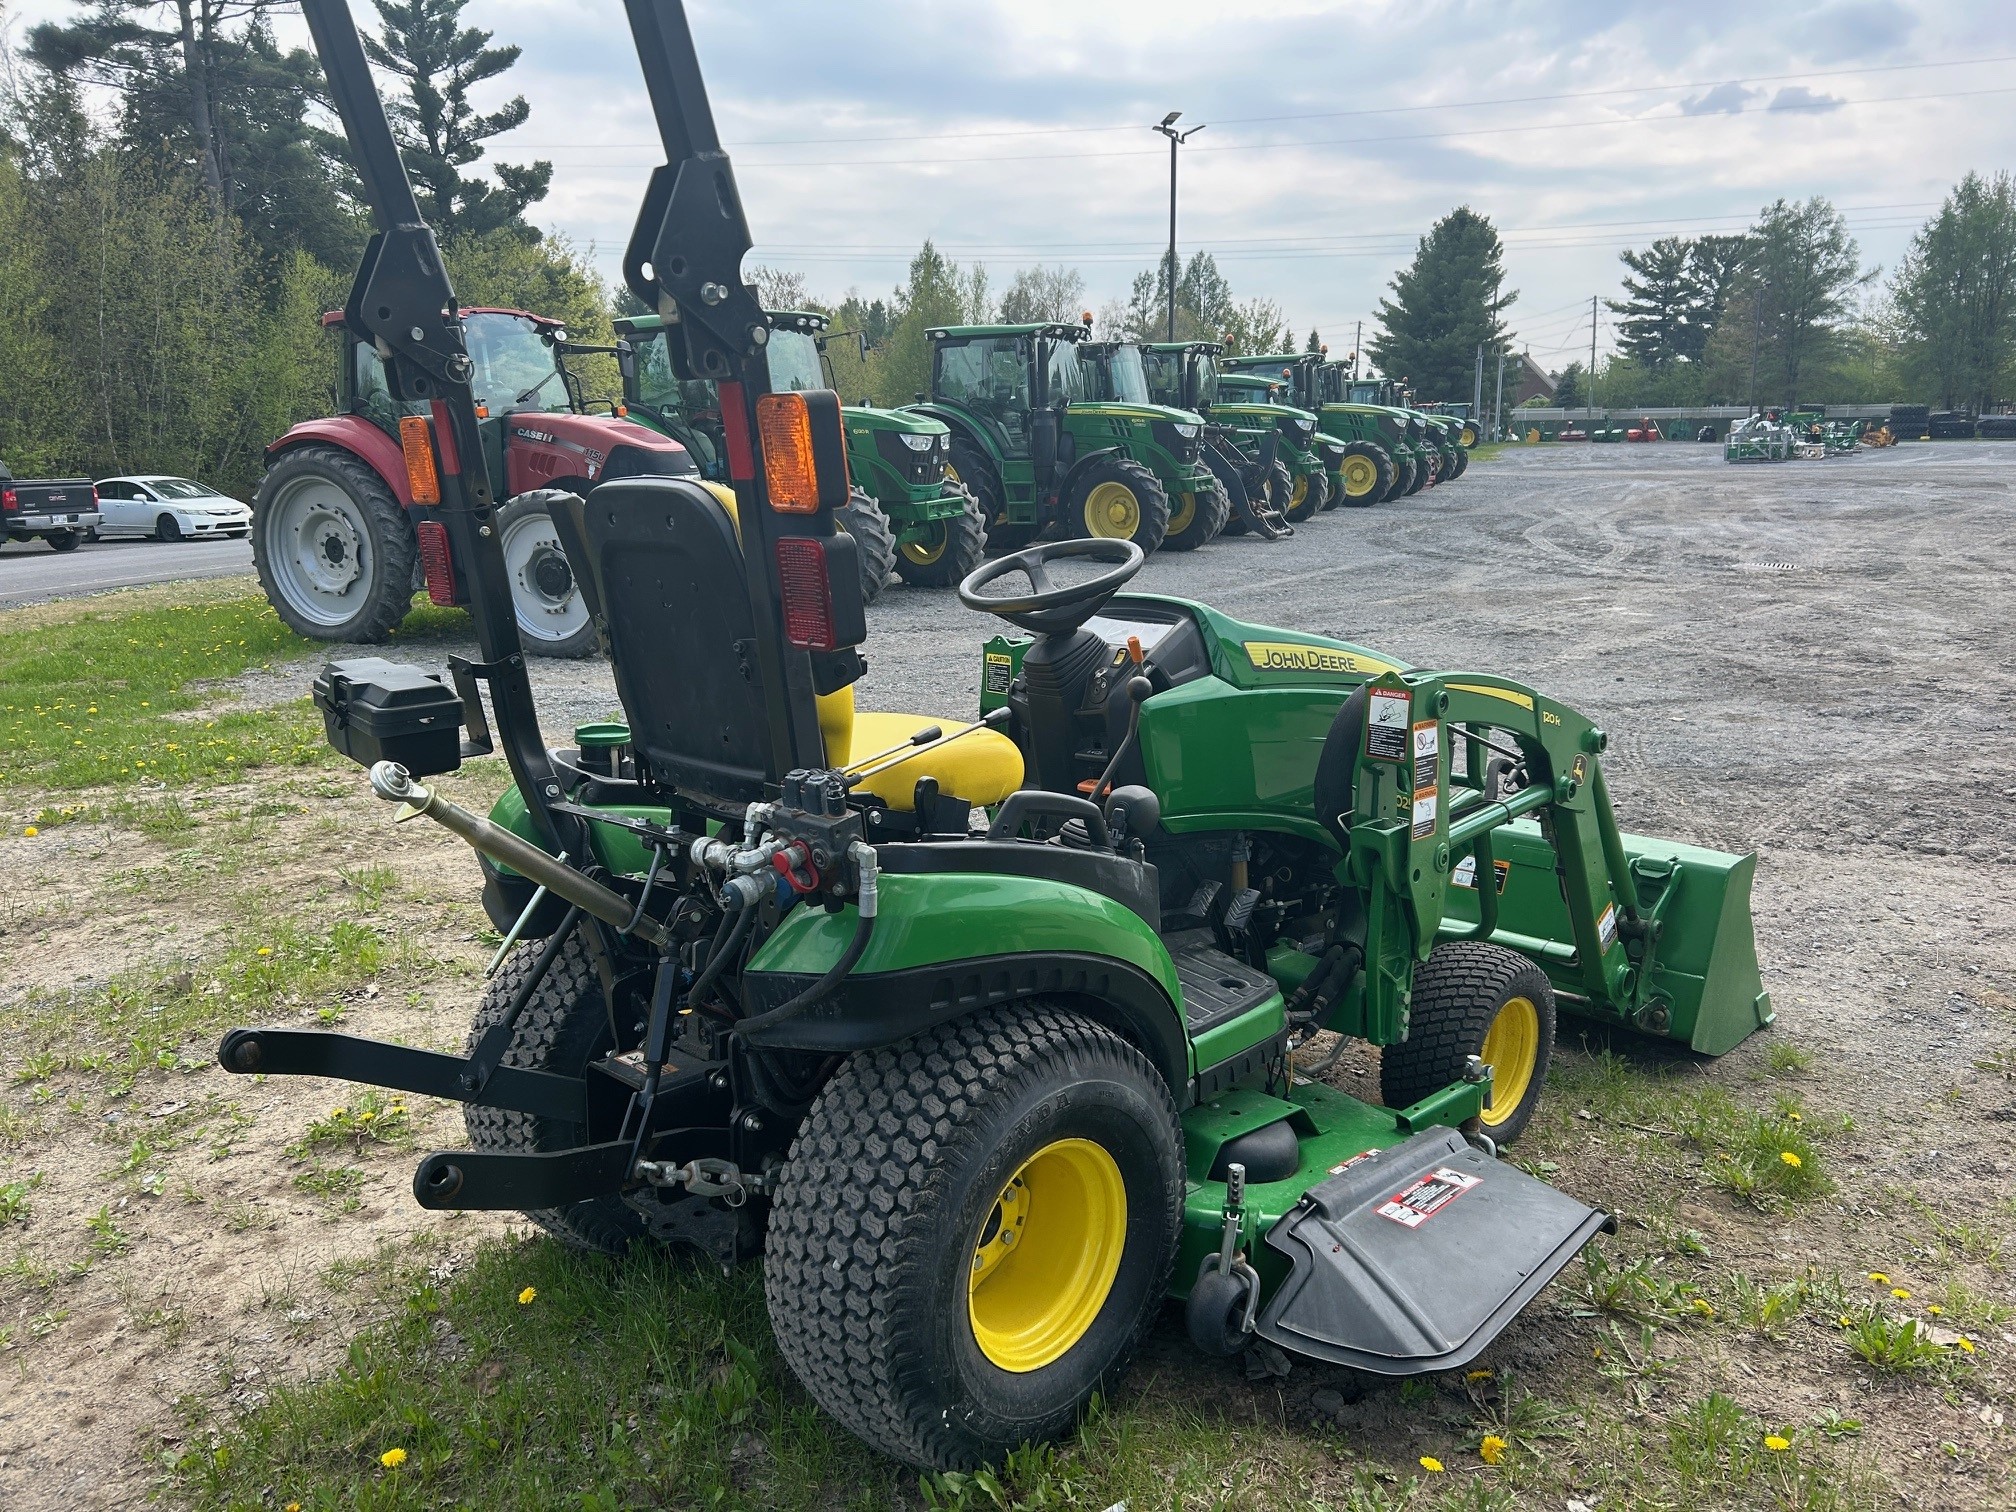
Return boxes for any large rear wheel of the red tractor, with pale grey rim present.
[252,446,419,641]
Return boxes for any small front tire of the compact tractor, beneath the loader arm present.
[1379,939,1554,1145]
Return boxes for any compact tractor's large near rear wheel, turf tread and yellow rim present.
[764,1002,1183,1470]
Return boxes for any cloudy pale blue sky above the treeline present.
[12,0,2016,367]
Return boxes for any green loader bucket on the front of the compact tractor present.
[1443,821,1772,1054]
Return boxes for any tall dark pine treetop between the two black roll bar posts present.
[363,0,552,238]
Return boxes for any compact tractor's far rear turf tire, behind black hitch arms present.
[462,931,645,1254]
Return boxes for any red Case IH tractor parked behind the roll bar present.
[252,308,698,657]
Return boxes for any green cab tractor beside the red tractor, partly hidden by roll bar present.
[615,310,988,601]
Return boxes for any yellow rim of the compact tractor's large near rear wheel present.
[966,1139,1127,1375]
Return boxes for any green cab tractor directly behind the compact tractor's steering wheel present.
[911,323,1226,552]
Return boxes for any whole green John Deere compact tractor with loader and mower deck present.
[220,0,1770,1468]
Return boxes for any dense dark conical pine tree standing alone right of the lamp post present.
[1369,206,1518,397]
